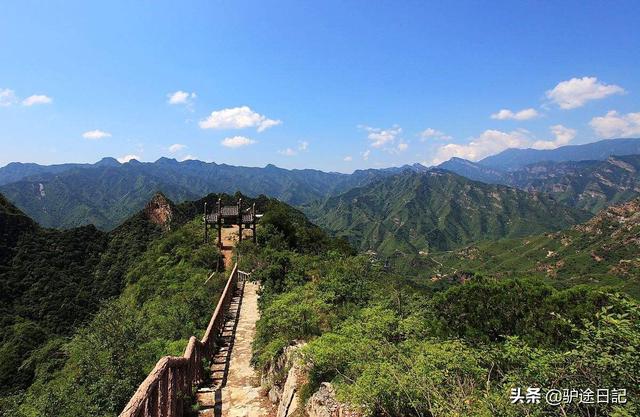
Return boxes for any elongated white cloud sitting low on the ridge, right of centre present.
[431,129,530,165]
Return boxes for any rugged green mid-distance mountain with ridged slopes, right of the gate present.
[308,170,587,254]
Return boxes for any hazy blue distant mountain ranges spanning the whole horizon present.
[0,139,640,230]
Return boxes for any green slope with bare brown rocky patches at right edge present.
[424,199,640,298]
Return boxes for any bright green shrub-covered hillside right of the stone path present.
[241,196,640,417]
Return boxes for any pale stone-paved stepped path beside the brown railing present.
[197,274,276,417]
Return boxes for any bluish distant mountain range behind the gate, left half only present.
[0,158,395,230]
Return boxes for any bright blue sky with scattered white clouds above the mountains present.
[0,0,640,172]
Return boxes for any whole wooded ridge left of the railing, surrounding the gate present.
[0,189,351,417]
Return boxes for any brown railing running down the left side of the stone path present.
[120,264,246,417]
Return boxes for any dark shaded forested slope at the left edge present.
[0,195,171,391]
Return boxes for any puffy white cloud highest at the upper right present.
[546,77,625,110]
